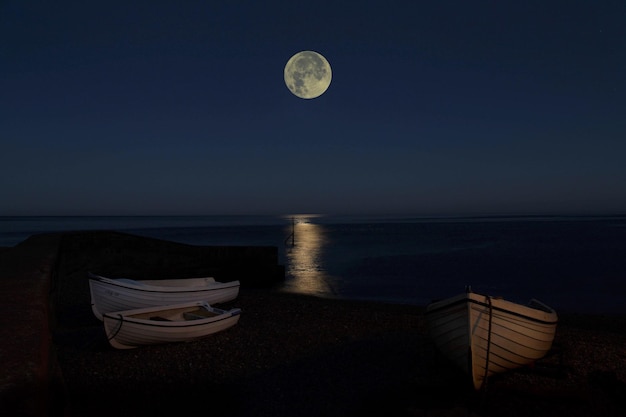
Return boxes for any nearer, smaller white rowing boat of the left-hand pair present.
[103,302,241,349]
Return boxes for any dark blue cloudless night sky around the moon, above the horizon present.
[0,0,626,215]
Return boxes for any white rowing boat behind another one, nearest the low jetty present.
[89,273,240,320]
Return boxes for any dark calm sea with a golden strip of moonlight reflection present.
[0,214,626,314]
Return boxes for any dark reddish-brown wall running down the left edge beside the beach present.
[0,235,63,416]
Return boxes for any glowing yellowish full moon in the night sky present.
[285,51,332,99]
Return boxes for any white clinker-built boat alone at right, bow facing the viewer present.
[426,292,558,389]
